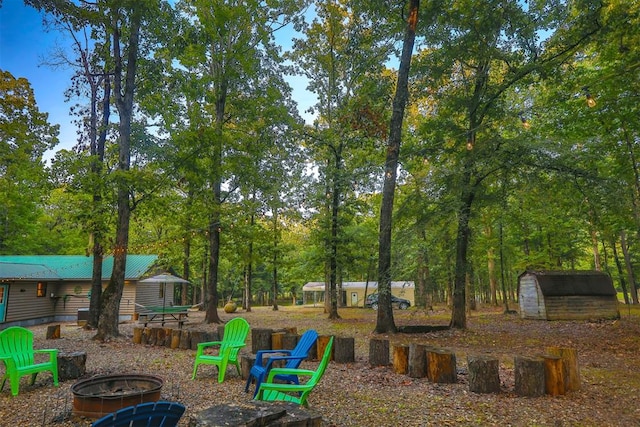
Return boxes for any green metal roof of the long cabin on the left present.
[0,255,158,280]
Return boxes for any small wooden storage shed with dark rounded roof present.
[518,271,620,320]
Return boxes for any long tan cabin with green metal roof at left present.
[0,255,158,329]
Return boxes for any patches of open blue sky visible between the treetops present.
[0,0,316,157]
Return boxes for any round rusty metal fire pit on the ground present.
[71,374,164,418]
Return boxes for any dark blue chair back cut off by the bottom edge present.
[91,400,186,427]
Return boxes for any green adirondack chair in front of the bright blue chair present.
[256,337,333,406]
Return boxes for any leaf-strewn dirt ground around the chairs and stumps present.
[0,306,640,427]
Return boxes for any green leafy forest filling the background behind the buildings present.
[0,0,640,334]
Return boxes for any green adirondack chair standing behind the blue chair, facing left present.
[191,317,249,383]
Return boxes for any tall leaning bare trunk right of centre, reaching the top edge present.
[375,0,420,333]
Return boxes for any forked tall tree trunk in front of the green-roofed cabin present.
[94,3,143,341]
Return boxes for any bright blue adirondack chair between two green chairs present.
[244,329,318,397]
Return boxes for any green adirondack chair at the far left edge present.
[0,326,58,396]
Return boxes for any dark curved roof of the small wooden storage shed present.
[520,271,616,296]
